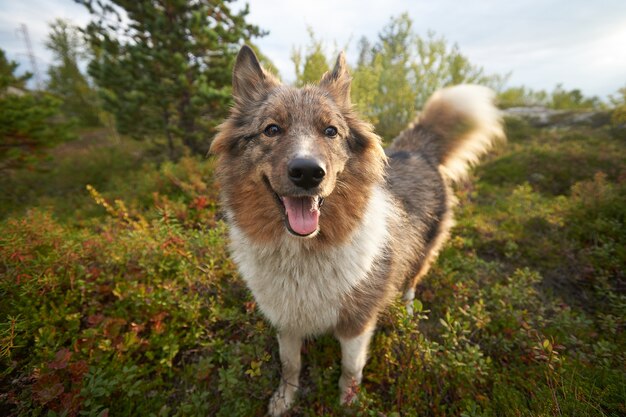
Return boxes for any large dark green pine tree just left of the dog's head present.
[76,0,264,157]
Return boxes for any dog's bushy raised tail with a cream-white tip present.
[390,85,505,182]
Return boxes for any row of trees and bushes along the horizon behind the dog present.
[0,0,626,170]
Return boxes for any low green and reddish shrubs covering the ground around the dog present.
[0,120,626,417]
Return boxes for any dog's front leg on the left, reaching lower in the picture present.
[269,333,302,416]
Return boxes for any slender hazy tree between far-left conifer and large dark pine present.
[46,19,100,126]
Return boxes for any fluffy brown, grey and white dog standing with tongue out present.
[211,46,504,416]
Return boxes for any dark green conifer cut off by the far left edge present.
[0,49,73,171]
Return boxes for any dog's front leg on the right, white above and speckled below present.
[337,325,375,404]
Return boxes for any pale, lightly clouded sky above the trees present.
[0,0,626,98]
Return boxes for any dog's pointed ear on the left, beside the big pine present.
[233,45,280,103]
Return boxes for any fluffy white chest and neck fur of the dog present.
[230,188,392,336]
